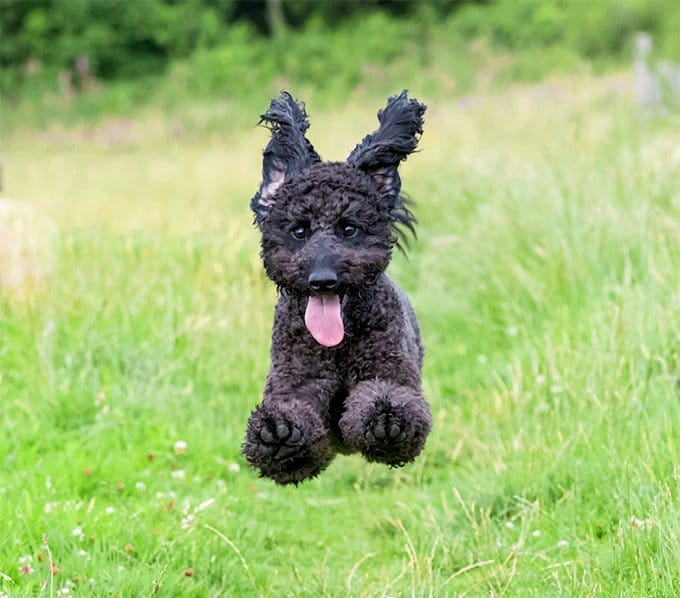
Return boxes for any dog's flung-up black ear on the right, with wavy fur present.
[347,90,427,202]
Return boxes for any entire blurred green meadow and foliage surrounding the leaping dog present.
[0,0,680,598]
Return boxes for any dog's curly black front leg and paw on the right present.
[339,378,432,467]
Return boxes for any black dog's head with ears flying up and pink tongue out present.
[250,91,426,346]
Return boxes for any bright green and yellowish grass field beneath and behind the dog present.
[0,75,680,596]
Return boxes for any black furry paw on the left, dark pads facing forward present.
[242,402,334,484]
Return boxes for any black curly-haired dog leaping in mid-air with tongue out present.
[243,91,431,484]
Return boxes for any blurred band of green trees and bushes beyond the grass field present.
[0,0,680,131]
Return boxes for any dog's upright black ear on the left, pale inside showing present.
[250,91,321,225]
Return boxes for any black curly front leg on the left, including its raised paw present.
[243,380,335,484]
